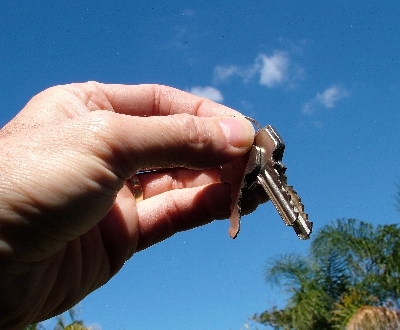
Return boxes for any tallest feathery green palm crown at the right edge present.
[311,219,400,308]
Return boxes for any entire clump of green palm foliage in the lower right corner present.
[253,219,400,330]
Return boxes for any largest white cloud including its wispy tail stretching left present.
[214,51,298,88]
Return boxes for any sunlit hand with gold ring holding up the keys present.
[0,82,254,329]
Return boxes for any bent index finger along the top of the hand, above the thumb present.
[96,83,242,117]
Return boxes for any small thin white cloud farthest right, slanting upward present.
[303,85,350,114]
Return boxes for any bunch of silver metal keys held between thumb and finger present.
[221,118,313,240]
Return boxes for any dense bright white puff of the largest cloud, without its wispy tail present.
[257,52,289,88]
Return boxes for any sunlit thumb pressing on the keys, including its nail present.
[83,111,255,178]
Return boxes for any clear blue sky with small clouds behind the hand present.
[0,0,400,330]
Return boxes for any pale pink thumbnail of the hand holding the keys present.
[219,117,255,148]
